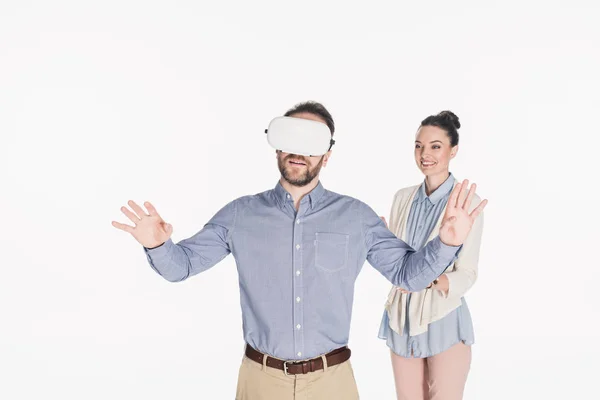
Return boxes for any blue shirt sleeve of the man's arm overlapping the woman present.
[360,205,460,292]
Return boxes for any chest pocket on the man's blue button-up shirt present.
[315,232,350,272]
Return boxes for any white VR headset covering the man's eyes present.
[265,117,335,157]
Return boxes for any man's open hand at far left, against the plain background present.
[112,200,173,249]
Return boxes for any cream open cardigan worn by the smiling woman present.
[385,180,483,336]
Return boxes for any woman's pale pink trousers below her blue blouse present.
[392,342,471,400]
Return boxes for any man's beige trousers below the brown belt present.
[235,356,359,400]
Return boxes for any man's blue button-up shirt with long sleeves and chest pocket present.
[145,183,458,360]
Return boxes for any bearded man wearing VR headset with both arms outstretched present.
[113,102,486,400]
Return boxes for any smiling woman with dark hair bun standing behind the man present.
[379,111,483,400]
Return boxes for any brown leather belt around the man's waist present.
[246,345,351,375]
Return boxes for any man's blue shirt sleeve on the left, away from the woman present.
[144,201,237,282]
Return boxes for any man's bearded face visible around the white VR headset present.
[277,113,331,187]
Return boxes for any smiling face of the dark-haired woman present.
[415,126,458,176]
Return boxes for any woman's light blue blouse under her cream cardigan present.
[379,174,475,358]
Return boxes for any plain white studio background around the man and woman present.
[0,0,600,400]
